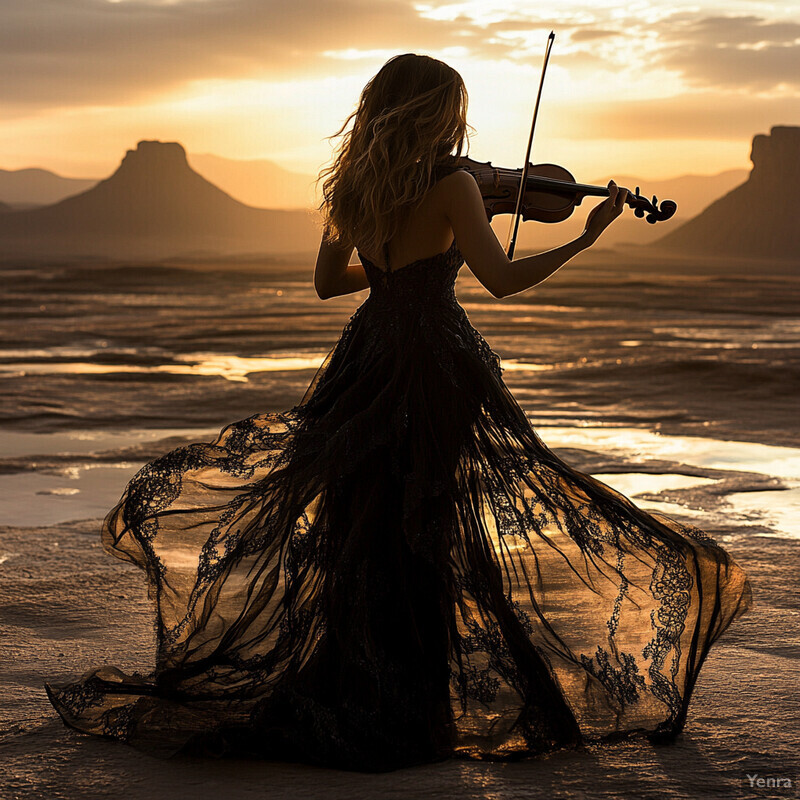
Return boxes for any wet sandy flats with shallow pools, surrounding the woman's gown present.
[0,251,800,800]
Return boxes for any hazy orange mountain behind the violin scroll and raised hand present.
[510,169,747,250]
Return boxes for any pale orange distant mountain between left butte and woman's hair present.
[188,153,317,208]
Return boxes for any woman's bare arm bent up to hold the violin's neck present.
[439,170,627,297]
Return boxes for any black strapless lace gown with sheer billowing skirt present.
[47,242,751,771]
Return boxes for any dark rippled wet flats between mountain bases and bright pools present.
[0,259,800,454]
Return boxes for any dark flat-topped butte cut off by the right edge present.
[656,126,800,259]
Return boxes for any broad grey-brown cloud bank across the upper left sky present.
[0,0,476,110]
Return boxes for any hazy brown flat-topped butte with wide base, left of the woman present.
[0,141,319,259]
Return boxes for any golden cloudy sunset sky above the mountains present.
[0,0,800,180]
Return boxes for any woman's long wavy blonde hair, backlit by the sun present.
[317,53,469,254]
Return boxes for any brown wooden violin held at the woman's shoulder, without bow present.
[456,156,678,225]
